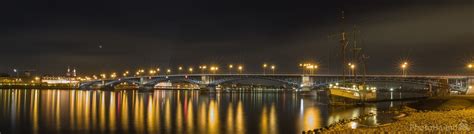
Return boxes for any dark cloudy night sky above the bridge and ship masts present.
[0,0,474,74]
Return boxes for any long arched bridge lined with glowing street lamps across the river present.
[79,74,474,93]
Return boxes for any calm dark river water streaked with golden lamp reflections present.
[0,89,422,134]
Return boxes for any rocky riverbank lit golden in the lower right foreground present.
[316,96,474,133]
